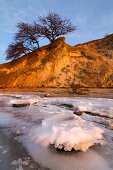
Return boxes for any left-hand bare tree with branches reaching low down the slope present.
[6,22,41,60]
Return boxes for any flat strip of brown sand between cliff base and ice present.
[0,88,113,99]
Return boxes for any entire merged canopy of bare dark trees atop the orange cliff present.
[6,13,77,60]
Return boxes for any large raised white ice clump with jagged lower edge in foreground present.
[31,113,104,151]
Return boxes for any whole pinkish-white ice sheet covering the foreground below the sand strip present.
[0,94,113,170]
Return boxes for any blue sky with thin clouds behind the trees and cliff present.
[0,0,113,63]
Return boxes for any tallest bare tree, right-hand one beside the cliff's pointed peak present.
[38,13,77,42]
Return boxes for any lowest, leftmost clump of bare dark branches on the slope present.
[6,42,32,60]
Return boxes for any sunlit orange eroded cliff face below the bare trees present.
[0,34,113,88]
